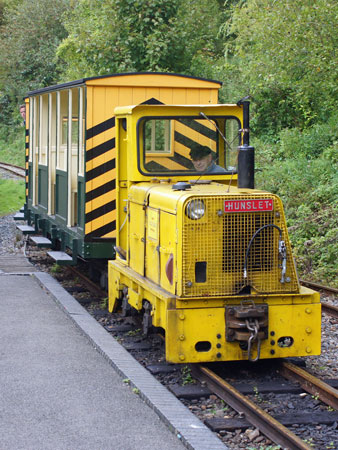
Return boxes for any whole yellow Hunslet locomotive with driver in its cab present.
[108,102,321,363]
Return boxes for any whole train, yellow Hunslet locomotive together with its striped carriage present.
[25,74,321,363]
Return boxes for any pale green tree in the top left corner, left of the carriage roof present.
[0,0,70,125]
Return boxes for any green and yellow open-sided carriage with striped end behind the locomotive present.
[24,73,221,264]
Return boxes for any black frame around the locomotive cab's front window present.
[136,114,242,177]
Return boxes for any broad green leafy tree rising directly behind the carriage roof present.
[58,0,226,79]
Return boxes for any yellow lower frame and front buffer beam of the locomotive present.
[109,260,321,363]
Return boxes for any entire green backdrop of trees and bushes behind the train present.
[0,0,338,286]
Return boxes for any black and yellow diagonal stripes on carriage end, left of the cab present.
[85,117,116,241]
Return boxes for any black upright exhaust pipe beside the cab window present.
[237,99,255,189]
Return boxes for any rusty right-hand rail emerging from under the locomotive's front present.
[279,361,338,410]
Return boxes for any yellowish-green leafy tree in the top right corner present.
[222,0,338,134]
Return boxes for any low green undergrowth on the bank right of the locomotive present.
[257,145,338,286]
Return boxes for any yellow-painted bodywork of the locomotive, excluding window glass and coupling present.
[108,105,321,363]
